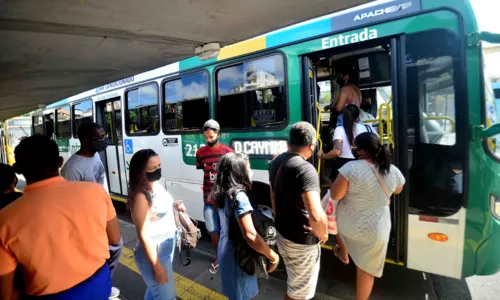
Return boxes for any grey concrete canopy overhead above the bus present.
[0,0,370,120]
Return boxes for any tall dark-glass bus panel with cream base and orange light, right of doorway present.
[395,29,468,278]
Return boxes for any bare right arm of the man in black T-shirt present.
[301,191,328,243]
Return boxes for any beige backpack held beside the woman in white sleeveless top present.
[174,205,201,266]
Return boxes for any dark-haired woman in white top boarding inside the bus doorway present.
[318,104,375,181]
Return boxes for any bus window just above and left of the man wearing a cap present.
[163,72,210,132]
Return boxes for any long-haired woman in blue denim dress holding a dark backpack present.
[212,152,279,300]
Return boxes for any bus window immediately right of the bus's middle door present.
[125,84,160,135]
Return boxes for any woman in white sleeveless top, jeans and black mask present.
[128,149,184,300]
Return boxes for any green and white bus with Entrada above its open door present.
[22,0,500,278]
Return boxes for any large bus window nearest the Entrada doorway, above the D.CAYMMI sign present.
[215,55,287,129]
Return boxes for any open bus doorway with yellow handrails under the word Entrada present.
[301,38,409,265]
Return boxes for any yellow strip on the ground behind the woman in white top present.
[120,247,227,300]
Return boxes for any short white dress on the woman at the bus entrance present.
[337,160,405,277]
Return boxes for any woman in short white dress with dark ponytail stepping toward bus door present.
[330,132,405,300]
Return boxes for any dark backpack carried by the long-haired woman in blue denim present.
[229,190,278,278]
